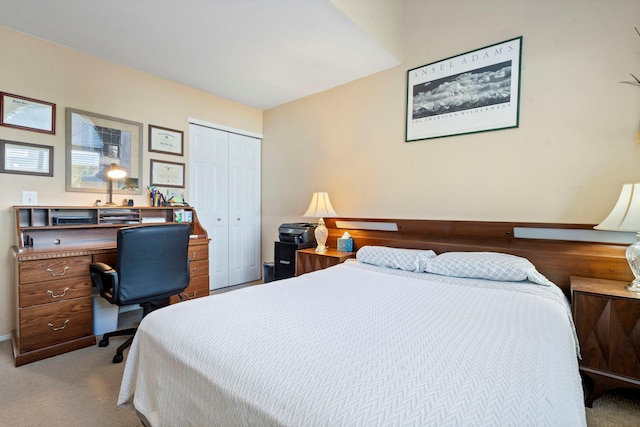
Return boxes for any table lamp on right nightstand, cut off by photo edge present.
[593,182,640,292]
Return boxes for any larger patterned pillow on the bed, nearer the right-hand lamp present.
[423,252,551,285]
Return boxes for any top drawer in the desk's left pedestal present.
[18,255,91,284]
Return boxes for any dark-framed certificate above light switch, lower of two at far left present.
[0,139,53,176]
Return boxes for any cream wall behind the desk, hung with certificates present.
[0,27,262,337]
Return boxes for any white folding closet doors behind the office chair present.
[189,124,261,289]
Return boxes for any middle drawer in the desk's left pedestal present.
[18,274,92,308]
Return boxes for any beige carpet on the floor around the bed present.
[0,338,640,427]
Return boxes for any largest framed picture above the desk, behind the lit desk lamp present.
[66,108,142,194]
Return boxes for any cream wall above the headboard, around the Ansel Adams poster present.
[263,0,640,260]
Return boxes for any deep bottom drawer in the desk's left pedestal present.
[18,296,93,352]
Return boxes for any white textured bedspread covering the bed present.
[118,263,586,426]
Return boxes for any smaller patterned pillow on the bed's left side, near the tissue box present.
[356,246,436,273]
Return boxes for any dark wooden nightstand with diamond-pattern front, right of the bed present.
[571,276,640,407]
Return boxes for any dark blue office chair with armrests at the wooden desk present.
[89,224,190,363]
